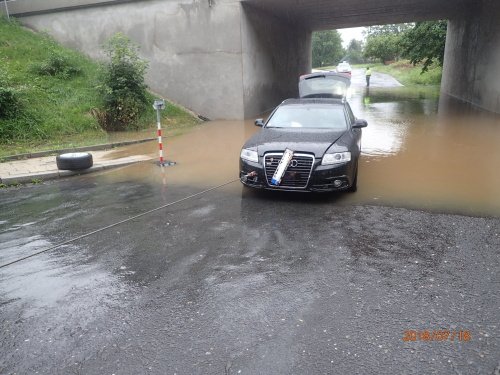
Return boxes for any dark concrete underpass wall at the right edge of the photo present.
[441,0,500,113]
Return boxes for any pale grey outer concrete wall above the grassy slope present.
[11,0,252,119]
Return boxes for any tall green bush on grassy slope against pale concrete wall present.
[96,33,149,130]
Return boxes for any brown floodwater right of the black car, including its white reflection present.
[350,88,500,215]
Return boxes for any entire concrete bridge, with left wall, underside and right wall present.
[4,0,500,119]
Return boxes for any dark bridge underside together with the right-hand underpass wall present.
[243,0,500,113]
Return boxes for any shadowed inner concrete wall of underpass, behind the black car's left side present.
[242,6,311,118]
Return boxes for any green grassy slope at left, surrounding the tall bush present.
[0,17,201,158]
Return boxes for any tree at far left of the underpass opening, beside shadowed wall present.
[312,30,344,67]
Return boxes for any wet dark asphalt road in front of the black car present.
[0,175,500,374]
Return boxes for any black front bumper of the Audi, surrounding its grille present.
[240,159,356,192]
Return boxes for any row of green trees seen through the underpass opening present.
[312,20,447,72]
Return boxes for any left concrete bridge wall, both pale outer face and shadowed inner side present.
[11,0,311,119]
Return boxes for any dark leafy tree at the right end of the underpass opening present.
[401,21,447,73]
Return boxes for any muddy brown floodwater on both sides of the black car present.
[103,88,500,216]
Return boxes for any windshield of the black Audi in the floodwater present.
[266,104,347,130]
